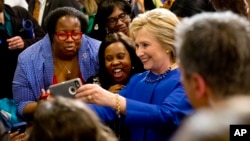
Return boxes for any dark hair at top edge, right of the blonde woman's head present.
[170,0,215,17]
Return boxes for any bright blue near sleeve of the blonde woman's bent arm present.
[125,83,192,128]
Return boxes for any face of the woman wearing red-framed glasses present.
[52,16,82,59]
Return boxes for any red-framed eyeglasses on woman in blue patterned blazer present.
[56,32,82,41]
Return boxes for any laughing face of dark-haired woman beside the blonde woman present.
[104,42,131,84]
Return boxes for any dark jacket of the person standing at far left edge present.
[0,5,45,99]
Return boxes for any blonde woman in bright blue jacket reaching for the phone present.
[76,8,192,141]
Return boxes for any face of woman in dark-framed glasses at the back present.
[107,6,131,35]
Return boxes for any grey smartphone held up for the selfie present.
[49,78,82,98]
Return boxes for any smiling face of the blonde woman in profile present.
[135,28,170,74]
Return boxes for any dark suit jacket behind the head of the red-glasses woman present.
[28,0,81,30]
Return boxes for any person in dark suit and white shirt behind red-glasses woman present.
[28,0,81,31]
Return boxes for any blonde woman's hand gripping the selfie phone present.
[75,84,115,106]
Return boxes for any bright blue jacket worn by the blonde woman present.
[90,69,193,141]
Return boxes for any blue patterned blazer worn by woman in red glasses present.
[12,35,101,115]
